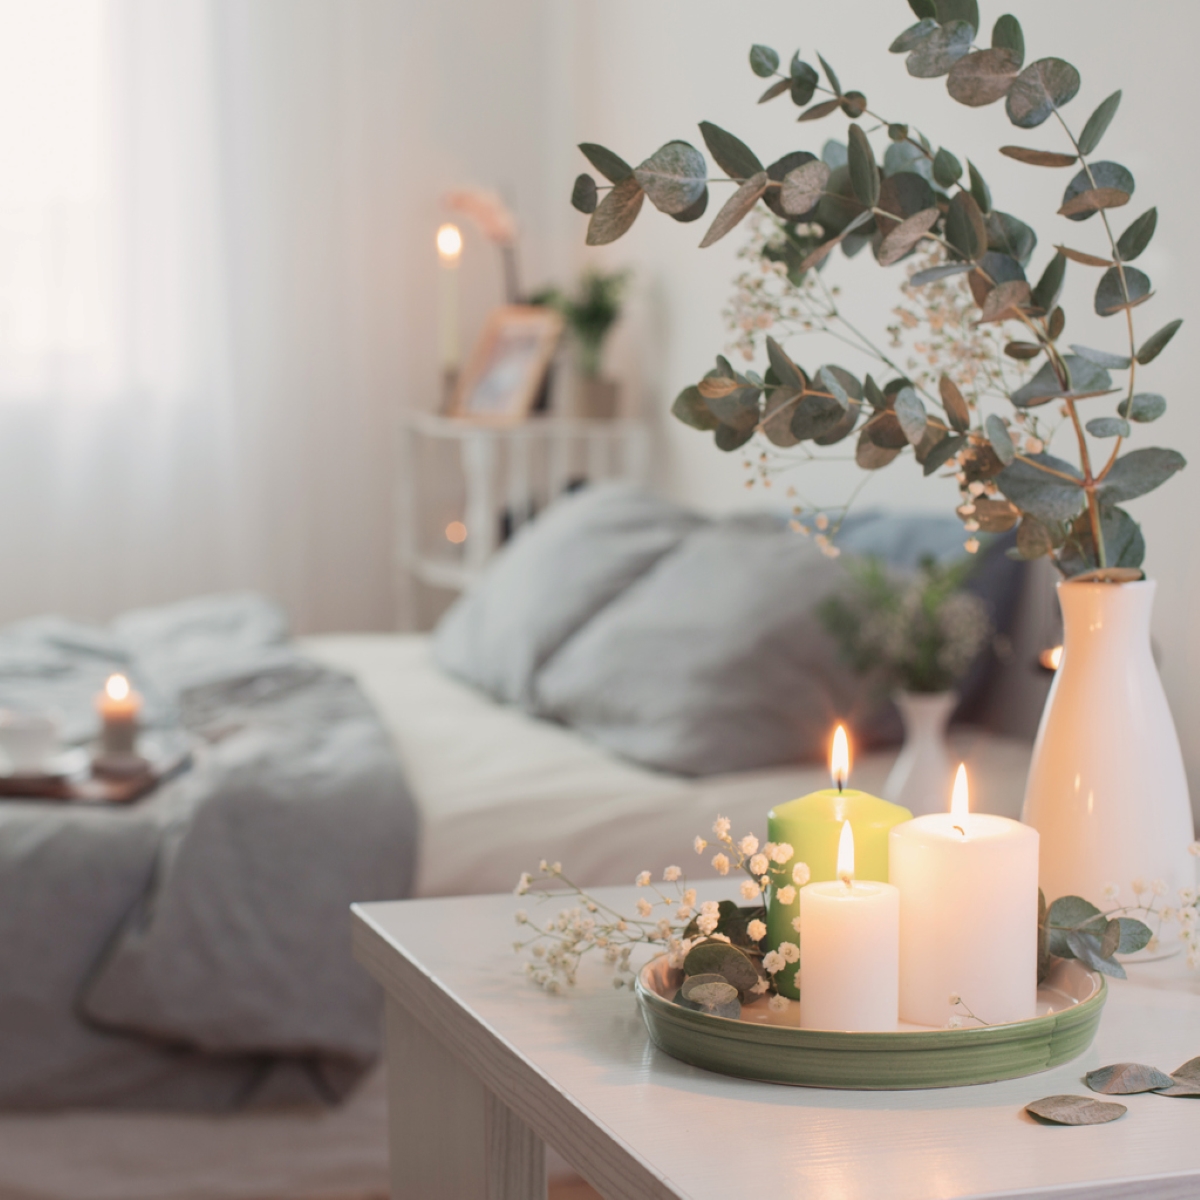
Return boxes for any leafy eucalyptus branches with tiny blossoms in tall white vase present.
[572,0,1194,916]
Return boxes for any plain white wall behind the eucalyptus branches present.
[558,0,1200,791]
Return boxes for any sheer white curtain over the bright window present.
[0,0,400,629]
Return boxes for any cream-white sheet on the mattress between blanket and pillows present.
[302,634,1031,896]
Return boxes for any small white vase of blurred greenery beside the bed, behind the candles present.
[817,558,991,816]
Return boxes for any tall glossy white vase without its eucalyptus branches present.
[1021,580,1195,904]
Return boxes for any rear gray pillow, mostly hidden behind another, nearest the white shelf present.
[433,484,703,708]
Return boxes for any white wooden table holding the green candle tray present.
[354,888,1200,1200]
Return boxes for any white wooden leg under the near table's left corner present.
[388,998,546,1200]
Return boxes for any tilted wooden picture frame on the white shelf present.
[449,305,563,424]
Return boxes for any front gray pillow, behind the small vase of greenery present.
[536,518,870,775]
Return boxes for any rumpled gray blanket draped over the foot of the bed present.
[0,596,418,1110]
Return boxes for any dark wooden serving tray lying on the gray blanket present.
[0,734,192,804]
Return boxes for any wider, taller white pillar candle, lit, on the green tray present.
[888,764,1038,1027]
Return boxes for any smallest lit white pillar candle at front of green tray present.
[799,821,900,1032]
